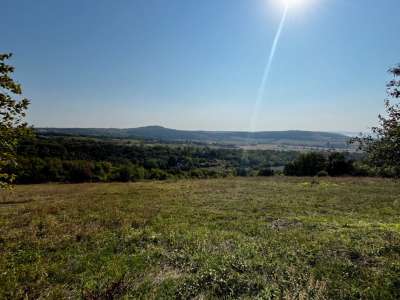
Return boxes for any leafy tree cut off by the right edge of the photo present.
[353,65,400,177]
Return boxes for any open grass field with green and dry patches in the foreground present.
[0,177,400,299]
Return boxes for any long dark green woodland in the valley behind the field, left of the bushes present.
[6,136,299,183]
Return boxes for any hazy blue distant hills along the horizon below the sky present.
[36,126,349,148]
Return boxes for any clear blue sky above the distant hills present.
[0,0,400,131]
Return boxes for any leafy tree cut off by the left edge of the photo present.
[0,54,29,188]
